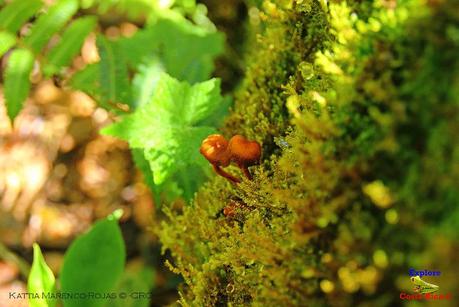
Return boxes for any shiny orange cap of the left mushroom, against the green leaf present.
[199,134,231,166]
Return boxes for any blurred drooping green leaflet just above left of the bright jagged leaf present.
[97,35,132,107]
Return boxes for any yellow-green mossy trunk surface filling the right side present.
[157,0,459,306]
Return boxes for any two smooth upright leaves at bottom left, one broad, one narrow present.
[28,211,126,307]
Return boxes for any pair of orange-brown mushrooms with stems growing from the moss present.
[199,134,261,183]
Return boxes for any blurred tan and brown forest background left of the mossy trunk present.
[0,0,246,306]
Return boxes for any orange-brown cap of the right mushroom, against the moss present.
[229,135,261,166]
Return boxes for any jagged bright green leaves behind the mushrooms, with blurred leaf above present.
[70,4,229,204]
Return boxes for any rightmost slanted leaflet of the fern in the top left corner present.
[44,16,97,76]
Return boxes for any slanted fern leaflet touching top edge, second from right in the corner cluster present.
[24,0,78,53]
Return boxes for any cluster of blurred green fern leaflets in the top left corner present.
[0,0,96,120]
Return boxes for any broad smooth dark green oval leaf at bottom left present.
[60,217,126,307]
